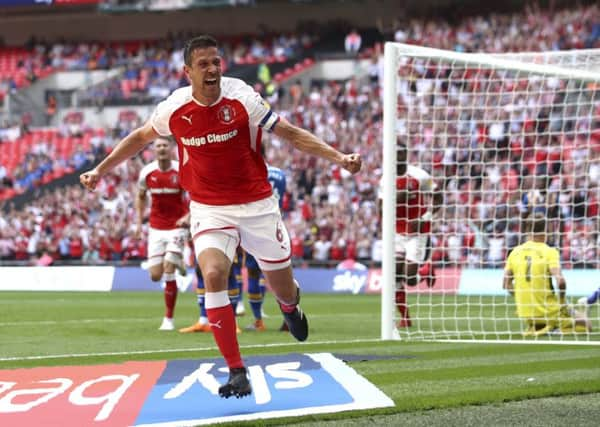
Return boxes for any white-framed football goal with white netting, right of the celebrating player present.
[381,43,600,342]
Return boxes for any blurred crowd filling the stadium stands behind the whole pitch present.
[0,0,600,268]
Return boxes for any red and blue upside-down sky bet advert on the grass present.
[0,353,393,427]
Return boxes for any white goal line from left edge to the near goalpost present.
[0,338,381,362]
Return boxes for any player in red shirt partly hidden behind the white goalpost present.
[380,141,443,328]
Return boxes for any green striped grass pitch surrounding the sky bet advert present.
[0,292,600,426]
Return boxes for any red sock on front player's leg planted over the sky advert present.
[206,304,244,369]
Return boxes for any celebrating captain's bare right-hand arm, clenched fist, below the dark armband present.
[273,118,362,173]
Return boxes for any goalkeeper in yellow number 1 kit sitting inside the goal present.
[503,214,591,336]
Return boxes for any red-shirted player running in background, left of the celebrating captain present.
[135,138,189,331]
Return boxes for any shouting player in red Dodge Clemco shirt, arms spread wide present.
[80,36,361,397]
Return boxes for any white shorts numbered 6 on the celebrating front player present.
[190,196,291,271]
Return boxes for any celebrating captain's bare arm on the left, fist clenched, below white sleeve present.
[79,122,159,190]
